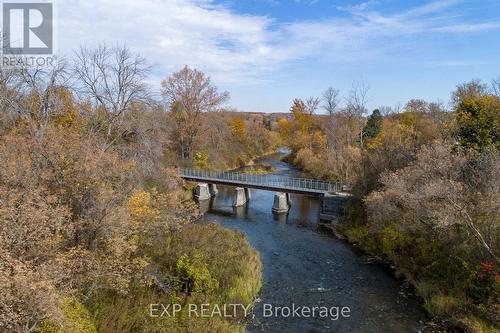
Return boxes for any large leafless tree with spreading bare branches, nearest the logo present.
[73,44,151,136]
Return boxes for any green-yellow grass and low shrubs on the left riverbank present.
[87,222,262,333]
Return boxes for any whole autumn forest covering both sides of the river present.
[0,45,500,332]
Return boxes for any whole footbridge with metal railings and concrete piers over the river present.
[180,169,345,220]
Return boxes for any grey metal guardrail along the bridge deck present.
[181,169,342,193]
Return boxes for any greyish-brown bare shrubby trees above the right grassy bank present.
[365,141,500,264]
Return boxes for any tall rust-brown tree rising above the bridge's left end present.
[162,66,229,160]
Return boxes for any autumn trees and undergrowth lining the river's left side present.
[0,45,271,332]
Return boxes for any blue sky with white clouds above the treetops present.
[56,0,500,112]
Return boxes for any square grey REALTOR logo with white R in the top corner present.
[2,1,54,55]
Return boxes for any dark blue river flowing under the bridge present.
[201,154,426,333]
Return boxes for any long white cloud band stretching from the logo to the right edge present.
[59,0,500,83]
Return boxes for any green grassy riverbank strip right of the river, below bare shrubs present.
[331,198,499,333]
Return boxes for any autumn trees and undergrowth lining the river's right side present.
[278,79,500,332]
